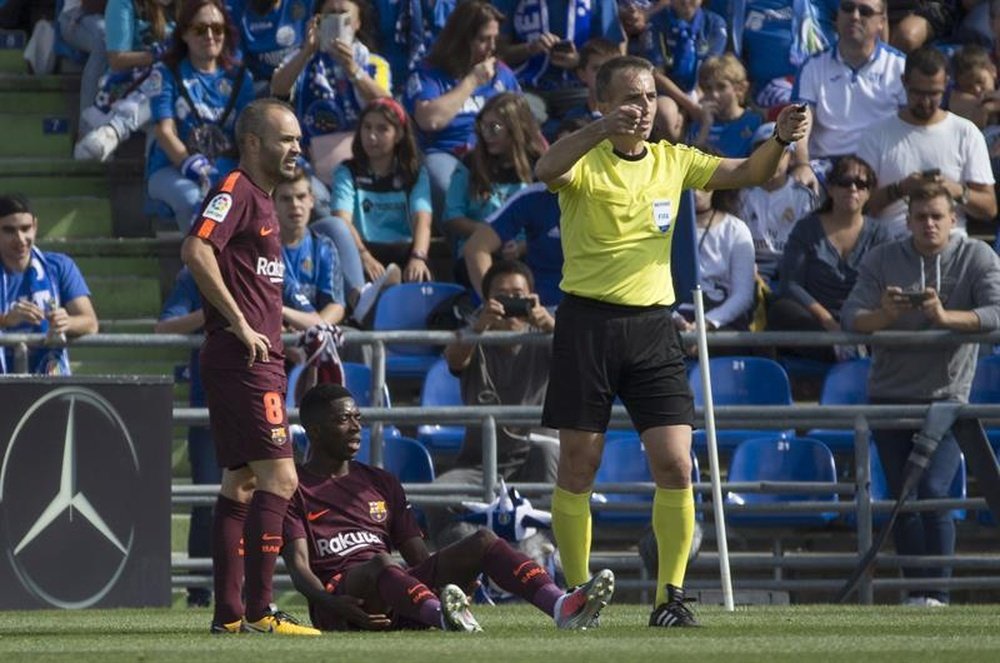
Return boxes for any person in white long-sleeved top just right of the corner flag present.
[676,189,756,331]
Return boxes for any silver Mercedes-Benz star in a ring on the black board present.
[0,386,139,608]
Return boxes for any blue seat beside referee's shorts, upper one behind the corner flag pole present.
[690,356,793,451]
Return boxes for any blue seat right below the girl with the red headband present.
[374,283,465,378]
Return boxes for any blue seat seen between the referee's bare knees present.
[592,429,703,525]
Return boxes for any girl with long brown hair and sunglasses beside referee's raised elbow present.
[444,92,546,285]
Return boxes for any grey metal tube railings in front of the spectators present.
[0,331,1000,603]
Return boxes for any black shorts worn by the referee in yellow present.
[542,295,694,433]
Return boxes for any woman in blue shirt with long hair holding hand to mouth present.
[405,0,521,226]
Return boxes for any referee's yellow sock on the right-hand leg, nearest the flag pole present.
[652,488,694,605]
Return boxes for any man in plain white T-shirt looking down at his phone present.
[858,47,997,237]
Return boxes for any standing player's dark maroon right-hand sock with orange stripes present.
[244,490,288,622]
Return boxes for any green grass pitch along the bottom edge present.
[0,604,1000,663]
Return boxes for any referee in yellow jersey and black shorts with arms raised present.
[535,56,809,626]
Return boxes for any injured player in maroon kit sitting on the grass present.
[282,384,614,631]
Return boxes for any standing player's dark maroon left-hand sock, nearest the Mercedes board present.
[212,495,249,624]
